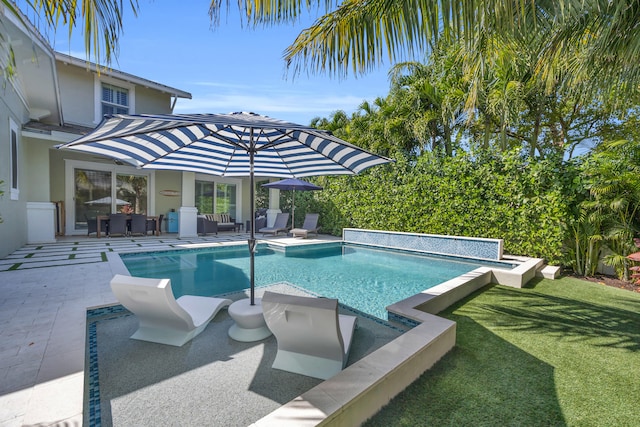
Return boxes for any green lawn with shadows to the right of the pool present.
[366,278,640,427]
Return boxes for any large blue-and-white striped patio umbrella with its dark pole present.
[57,113,391,304]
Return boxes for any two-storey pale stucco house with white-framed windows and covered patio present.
[0,7,270,258]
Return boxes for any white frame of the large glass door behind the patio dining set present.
[64,159,156,235]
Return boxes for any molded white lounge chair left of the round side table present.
[111,274,232,347]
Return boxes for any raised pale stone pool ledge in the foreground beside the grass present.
[252,313,456,427]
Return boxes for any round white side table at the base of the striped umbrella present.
[228,298,271,342]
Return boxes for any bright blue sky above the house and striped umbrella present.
[23,0,396,124]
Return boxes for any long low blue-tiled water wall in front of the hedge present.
[342,228,503,260]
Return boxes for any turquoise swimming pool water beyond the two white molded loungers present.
[120,243,508,319]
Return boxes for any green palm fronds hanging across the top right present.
[210,0,640,98]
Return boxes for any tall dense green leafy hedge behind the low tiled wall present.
[296,153,576,263]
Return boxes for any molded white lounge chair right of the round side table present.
[262,291,357,379]
